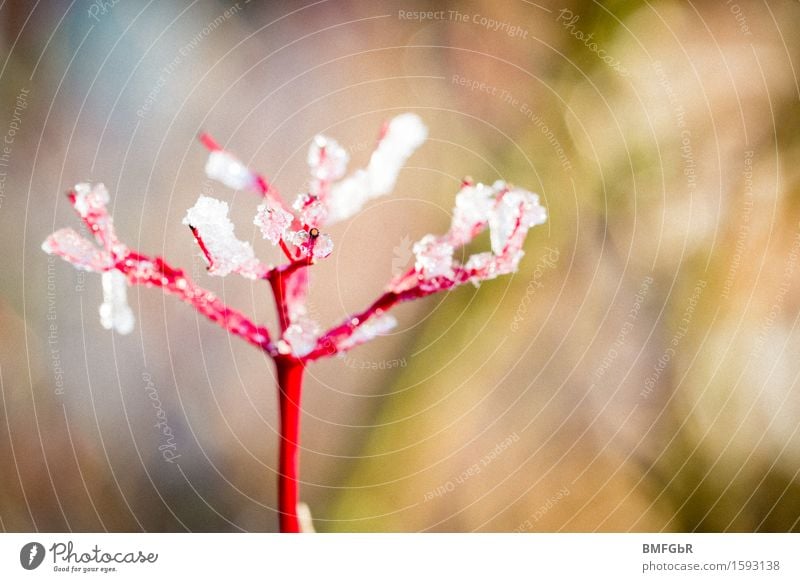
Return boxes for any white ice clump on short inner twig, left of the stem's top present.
[183,196,263,279]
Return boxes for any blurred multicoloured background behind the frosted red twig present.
[0,0,800,532]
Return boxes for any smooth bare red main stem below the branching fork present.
[275,357,305,533]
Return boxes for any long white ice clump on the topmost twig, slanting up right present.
[328,113,428,222]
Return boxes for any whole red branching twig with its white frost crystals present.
[43,114,546,532]
